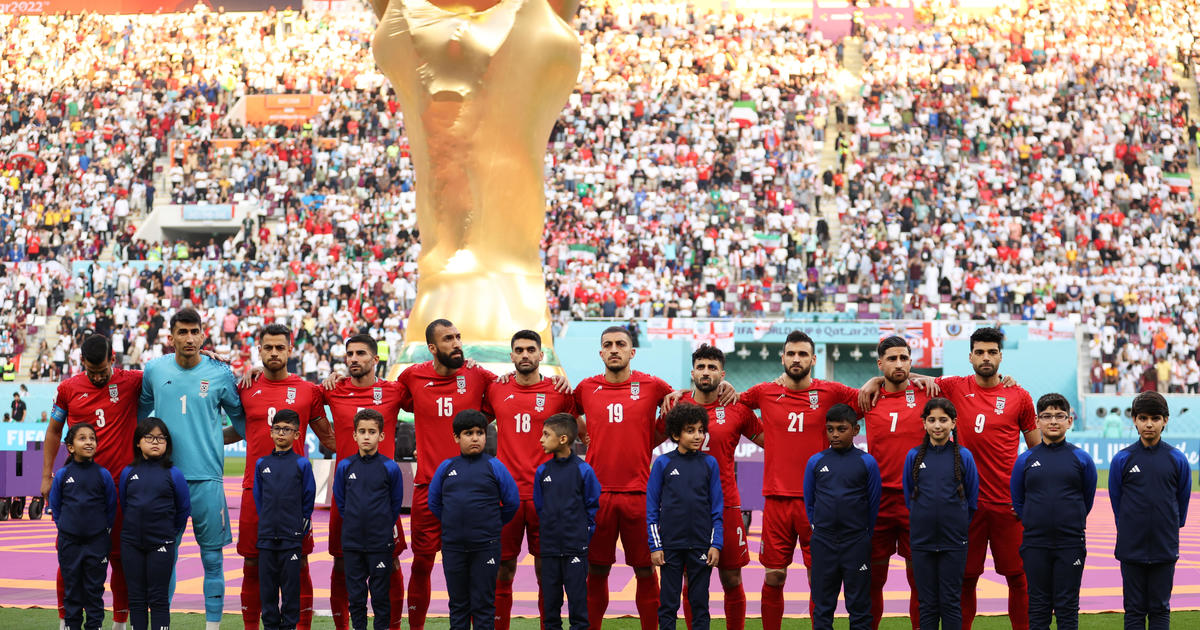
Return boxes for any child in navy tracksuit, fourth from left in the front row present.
[333,409,408,630]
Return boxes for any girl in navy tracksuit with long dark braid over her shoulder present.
[904,398,979,630]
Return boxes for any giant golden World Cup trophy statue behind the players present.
[372,0,580,362]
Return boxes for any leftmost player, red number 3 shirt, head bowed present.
[42,335,142,630]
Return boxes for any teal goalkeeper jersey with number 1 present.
[138,354,246,481]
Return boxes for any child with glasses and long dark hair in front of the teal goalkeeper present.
[119,418,192,630]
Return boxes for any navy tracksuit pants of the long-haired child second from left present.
[121,541,175,630]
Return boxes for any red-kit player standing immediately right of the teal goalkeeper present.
[236,324,337,630]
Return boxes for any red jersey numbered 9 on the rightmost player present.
[937,376,1037,504]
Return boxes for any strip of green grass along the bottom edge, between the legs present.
[0,608,1200,630]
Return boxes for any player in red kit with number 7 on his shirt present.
[864,336,929,630]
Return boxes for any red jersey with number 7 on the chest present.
[864,386,929,491]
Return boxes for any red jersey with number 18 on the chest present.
[487,378,575,500]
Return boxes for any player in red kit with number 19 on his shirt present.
[575,326,671,630]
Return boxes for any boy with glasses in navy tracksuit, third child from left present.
[253,409,317,630]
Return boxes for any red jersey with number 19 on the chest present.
[575,371,672,492]
